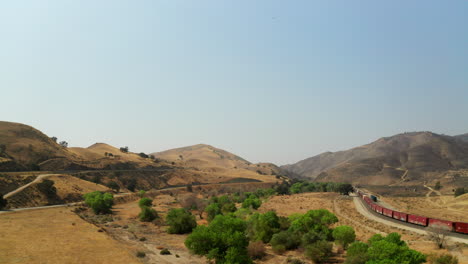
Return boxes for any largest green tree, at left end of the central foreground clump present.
[185,215,252,264]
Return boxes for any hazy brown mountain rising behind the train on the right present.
[282,132,468,185]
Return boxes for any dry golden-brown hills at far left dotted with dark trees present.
[0,121,163,171]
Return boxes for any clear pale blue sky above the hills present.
[0,0,468,164]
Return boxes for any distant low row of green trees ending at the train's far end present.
[289,181,354,195]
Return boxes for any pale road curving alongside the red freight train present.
[353,196,468,244]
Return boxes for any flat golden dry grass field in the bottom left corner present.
[0,208,140,264]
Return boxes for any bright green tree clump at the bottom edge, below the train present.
[345,233,426,264]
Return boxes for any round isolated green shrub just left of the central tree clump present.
[166,208,197,234]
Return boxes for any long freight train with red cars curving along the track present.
[356,190,468,234]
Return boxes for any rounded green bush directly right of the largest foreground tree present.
[247,211,280,243]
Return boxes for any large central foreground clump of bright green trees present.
[185,208,356,263]
